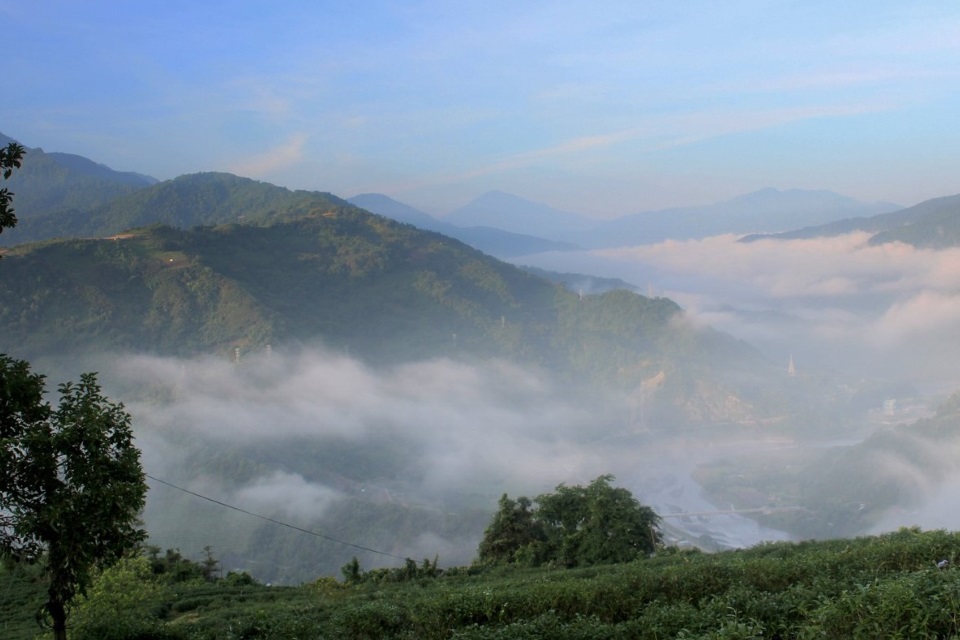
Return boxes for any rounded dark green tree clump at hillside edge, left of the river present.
[478,475,662,567]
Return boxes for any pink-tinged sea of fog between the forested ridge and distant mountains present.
[515,232,960,394]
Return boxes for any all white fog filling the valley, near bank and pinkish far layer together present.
[80,222,960,580]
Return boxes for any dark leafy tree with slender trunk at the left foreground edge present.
[0,355,147,640]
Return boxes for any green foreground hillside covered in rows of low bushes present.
[7,529,960,640]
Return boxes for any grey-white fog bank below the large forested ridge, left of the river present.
[104,349,633,572]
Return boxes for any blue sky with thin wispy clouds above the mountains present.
[0,0,960,218]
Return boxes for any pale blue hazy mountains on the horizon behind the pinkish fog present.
[362,184,960,251]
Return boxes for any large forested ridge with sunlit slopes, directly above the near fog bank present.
[0,198,780,419]
